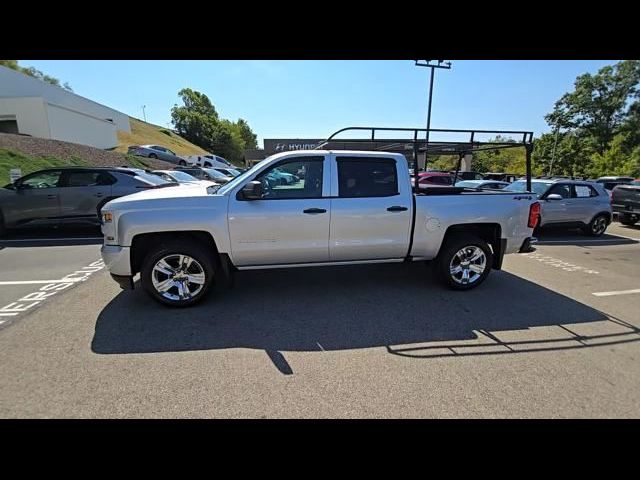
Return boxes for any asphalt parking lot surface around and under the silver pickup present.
[0,223,640,418]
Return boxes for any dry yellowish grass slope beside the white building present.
[115,117,206,155]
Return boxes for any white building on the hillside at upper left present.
[0,66,131,149]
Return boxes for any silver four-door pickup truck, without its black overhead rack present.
[102,150,540,307]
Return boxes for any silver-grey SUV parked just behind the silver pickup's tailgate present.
[503,179,613,237]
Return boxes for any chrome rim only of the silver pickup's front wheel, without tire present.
[151,254,206,301]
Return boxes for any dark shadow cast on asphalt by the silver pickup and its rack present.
[92,264,640,374]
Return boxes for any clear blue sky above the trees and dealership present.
[20,60,616,146]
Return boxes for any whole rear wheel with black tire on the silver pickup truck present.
[435,234,493,290]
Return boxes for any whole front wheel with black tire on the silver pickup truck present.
[140,240,215,307]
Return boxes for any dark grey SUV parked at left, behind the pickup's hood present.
[0,167,171,234]
